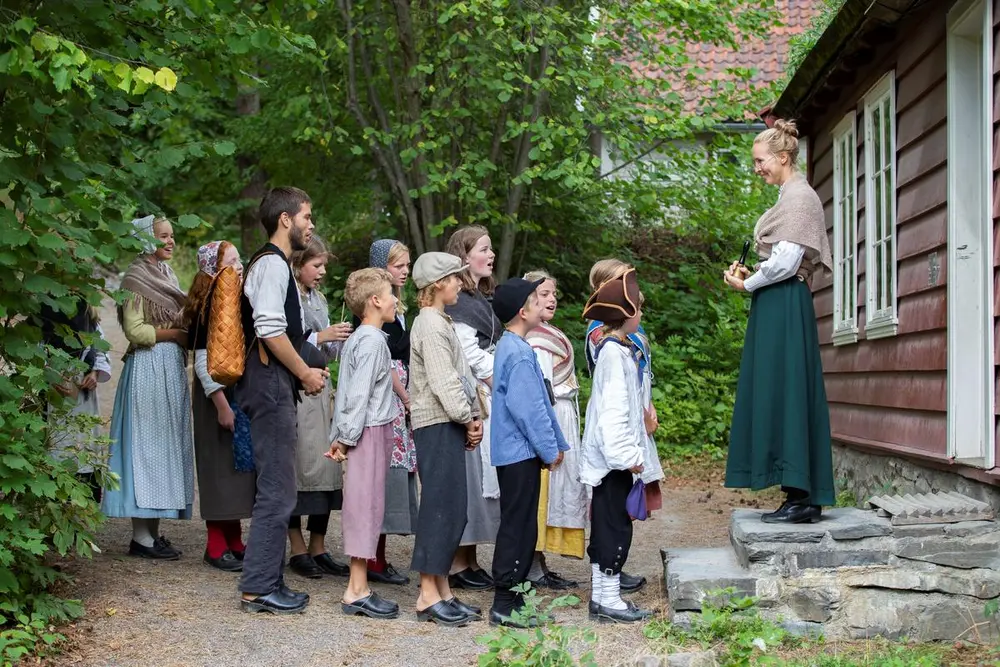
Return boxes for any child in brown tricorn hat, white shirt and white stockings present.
[580,268,650,623]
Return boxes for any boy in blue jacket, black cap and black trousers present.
[490,278,569,627]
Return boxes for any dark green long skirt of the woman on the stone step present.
[726,278,835,505]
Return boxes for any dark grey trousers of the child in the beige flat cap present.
[408,422,469,576]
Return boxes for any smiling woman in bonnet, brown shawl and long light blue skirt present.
[101,216,194,560]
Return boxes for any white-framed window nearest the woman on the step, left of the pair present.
[833,111,858,345]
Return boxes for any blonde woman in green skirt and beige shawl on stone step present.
[724,120,834,523]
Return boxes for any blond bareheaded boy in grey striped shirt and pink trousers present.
[329,269,399,618]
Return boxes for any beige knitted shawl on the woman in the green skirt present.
[753,173,833,278]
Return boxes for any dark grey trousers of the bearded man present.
[236,353,297,595]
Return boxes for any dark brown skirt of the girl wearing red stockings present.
[191,375,257,521]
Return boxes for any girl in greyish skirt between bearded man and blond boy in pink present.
[288,236,352,579]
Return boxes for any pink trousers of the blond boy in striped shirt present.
[340,423,393,559]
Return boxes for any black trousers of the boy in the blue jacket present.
[493,458,542,616]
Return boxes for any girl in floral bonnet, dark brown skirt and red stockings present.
[185,241,257,572]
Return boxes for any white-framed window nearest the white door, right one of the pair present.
[865,70,899,340]
